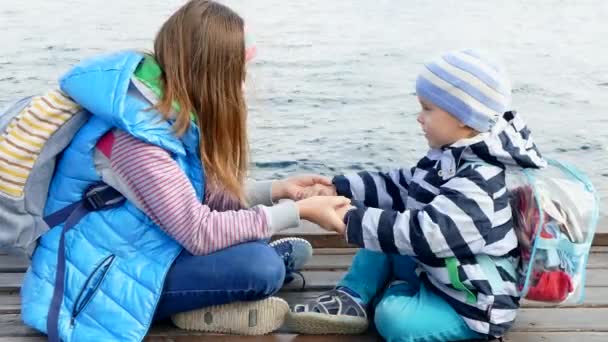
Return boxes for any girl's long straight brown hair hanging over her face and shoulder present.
[154,0,249,203]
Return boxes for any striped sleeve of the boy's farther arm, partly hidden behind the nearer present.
[333,169,412,211]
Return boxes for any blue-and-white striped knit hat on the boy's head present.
[416,50,511,132]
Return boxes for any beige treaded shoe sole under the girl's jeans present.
[171,297,289,335]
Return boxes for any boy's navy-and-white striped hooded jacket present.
[333,112,546,337]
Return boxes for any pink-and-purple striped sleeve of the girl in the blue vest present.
[110,131,270,255]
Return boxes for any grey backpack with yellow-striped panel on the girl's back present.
[0,90,122,256]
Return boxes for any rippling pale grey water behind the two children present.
[0,0,608,219]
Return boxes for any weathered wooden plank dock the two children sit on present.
[0,226,608,342]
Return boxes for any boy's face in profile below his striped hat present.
[418,97,476,148]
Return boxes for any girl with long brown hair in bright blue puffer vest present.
[22,0,349,341]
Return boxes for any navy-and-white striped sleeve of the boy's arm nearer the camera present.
[346,169,494,260]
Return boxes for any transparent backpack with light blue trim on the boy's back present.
[507,160,599,304]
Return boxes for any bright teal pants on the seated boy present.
[338,249,485,342]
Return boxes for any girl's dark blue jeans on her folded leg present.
[155,241,285,319]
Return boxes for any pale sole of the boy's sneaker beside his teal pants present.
[285,312,369,335]
